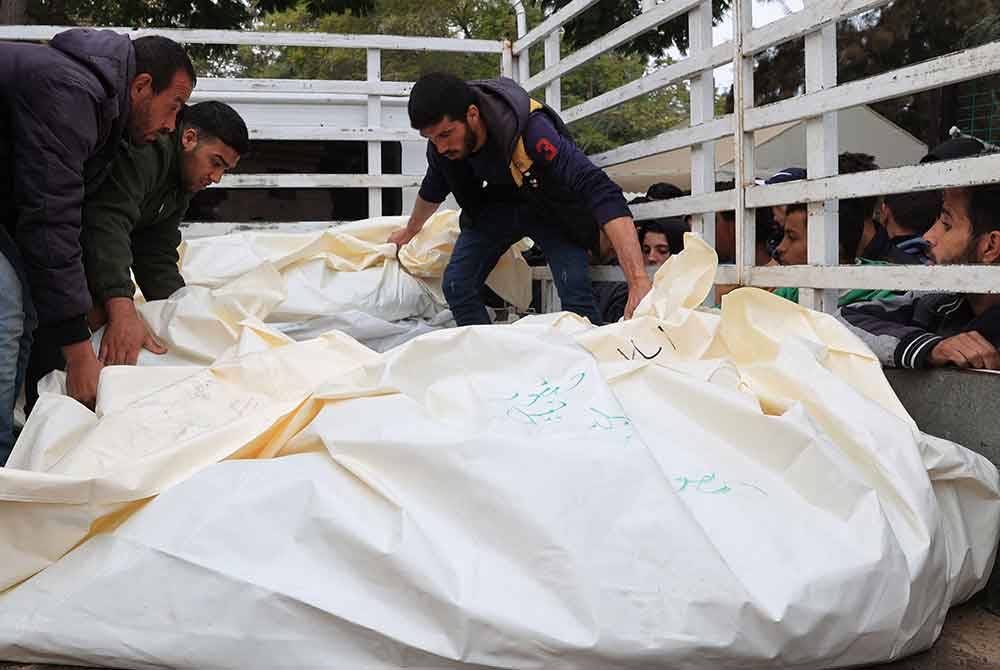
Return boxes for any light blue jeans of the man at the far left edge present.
[0,226,36,465]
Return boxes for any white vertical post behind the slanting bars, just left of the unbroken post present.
[688,0,715,247]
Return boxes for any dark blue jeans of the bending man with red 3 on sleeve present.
[443,203,600,326]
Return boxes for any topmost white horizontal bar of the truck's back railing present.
[0,26,503,54]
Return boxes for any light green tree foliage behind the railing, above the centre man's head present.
[239,0,688,153]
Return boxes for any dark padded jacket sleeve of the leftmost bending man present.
[10,73,101,345]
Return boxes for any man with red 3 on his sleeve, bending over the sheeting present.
[389,74,651,326]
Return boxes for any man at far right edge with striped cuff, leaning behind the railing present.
[839,184,1000,370]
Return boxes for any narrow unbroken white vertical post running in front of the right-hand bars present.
[733,0,757,284]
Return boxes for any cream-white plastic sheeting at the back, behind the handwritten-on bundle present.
[156,211,531,364]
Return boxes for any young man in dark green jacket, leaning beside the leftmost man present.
[81,101,250,365]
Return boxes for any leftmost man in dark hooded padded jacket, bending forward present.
[0,29,195,449]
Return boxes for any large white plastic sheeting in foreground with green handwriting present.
[0,237,1000,669]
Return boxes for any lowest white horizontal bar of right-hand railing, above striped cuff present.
[746,265,1000,293]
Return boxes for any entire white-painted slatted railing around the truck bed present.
[0,0,1000,310]
